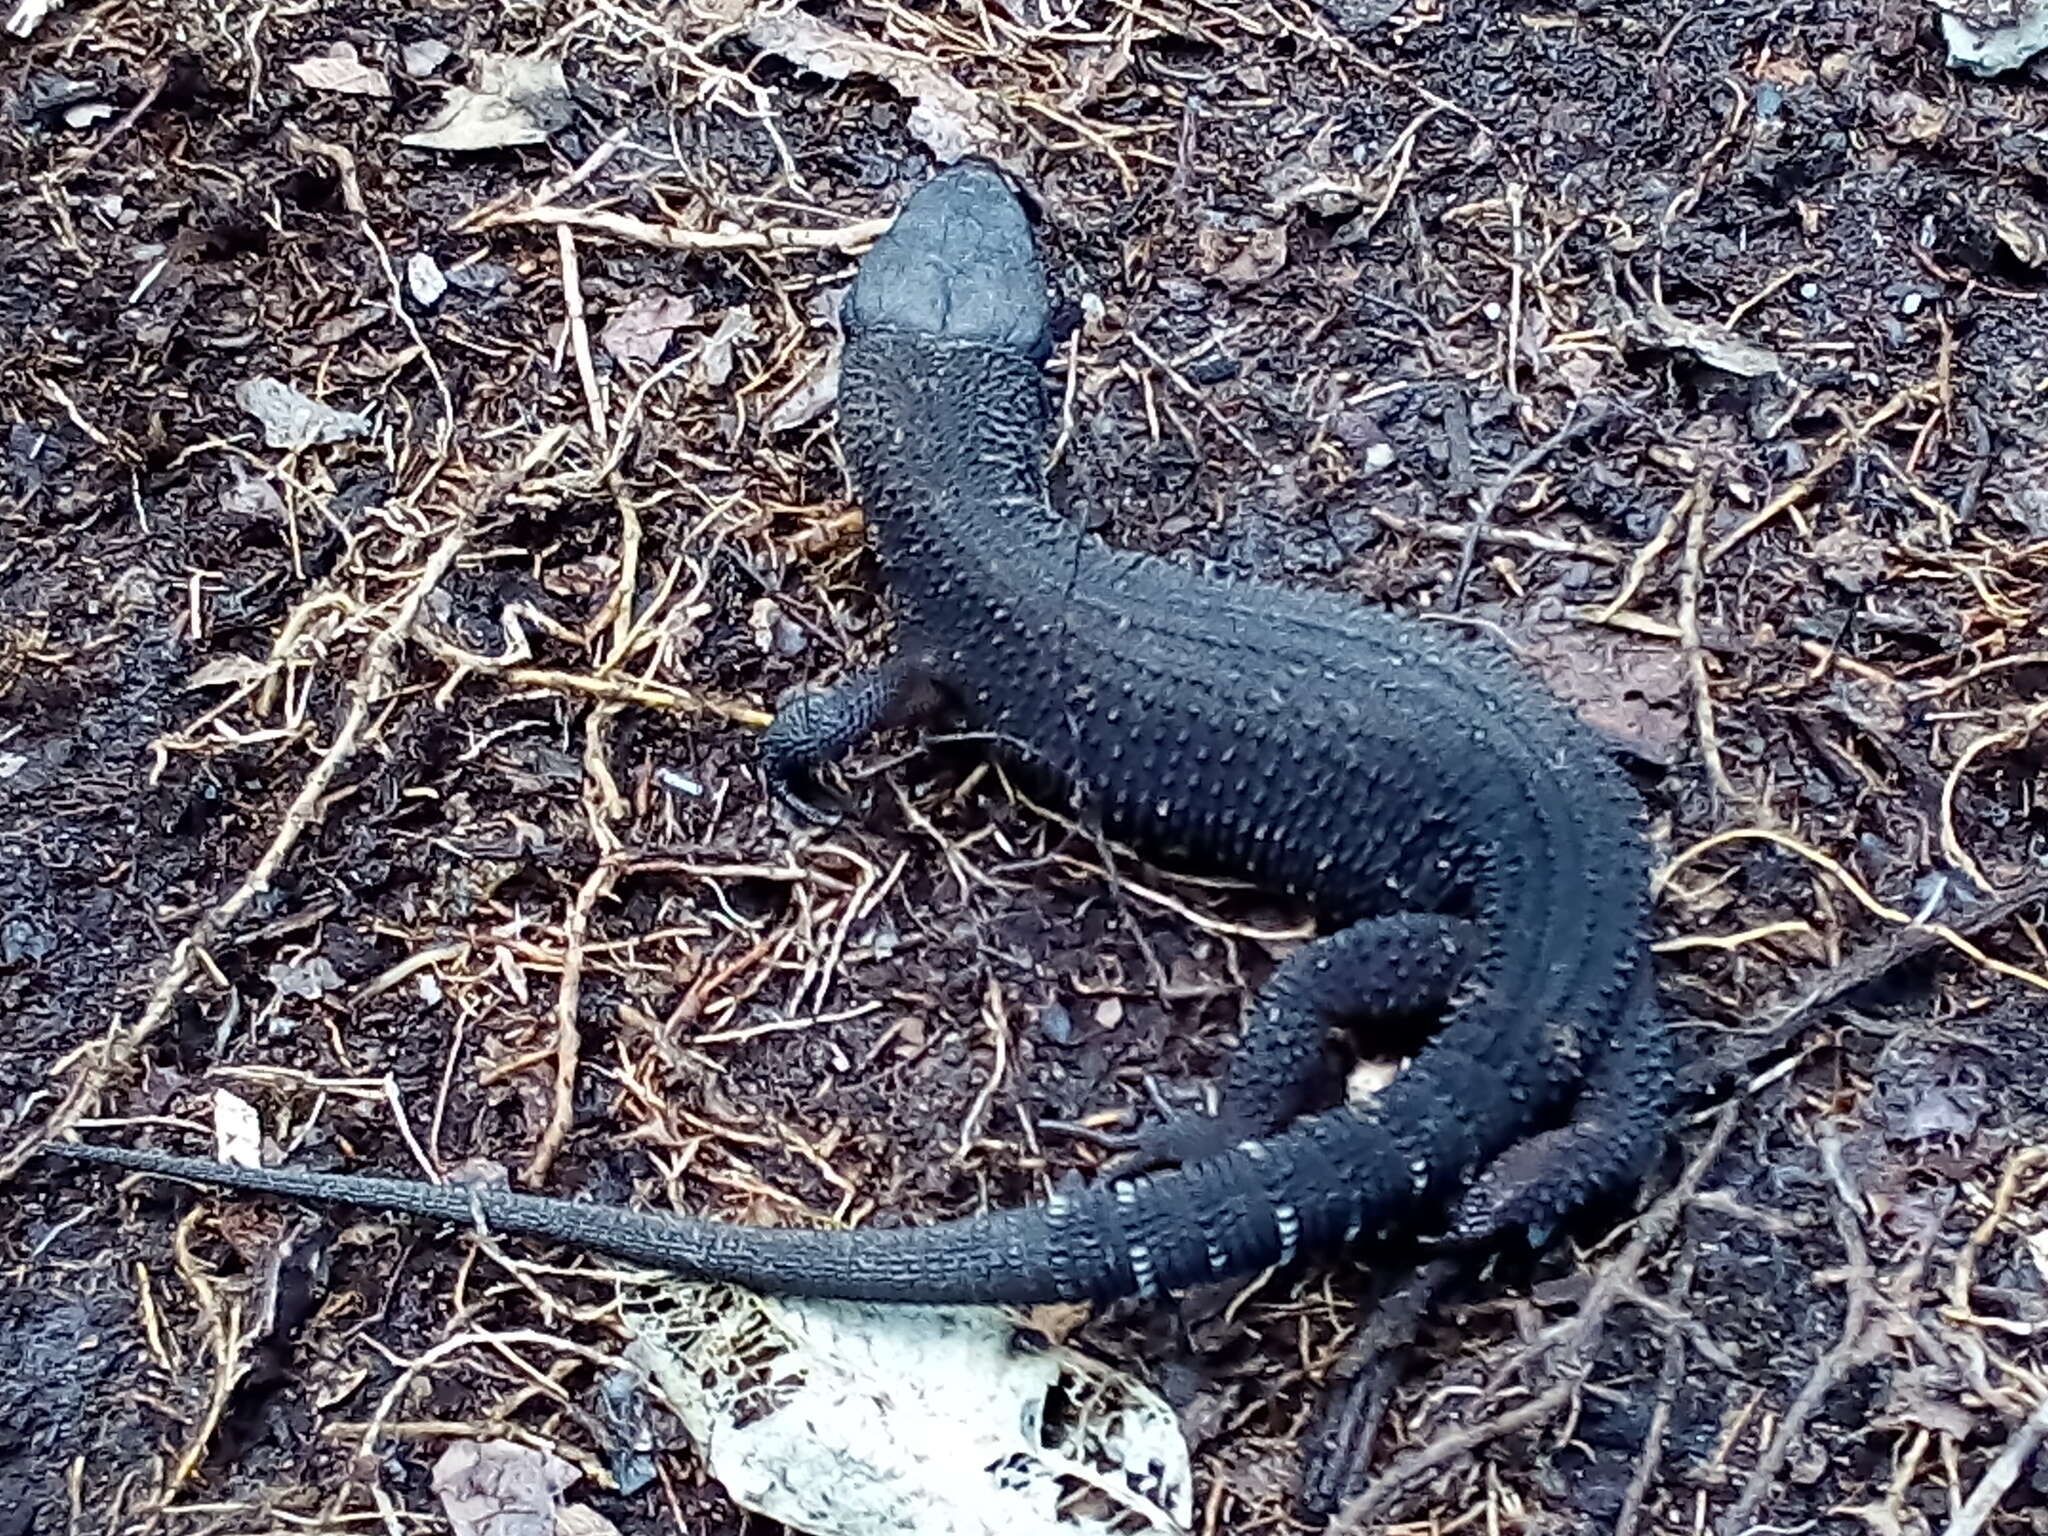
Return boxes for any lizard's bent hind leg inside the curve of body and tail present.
[1108,911,1483,1178]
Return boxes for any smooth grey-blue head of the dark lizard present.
[840,160,1053,358]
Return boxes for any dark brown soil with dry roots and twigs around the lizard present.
[0,0,2048,1536]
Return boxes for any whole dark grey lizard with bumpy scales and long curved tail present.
[51,162,1673,1303]
